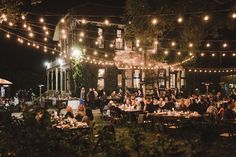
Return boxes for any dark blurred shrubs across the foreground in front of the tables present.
[0,107,235,157]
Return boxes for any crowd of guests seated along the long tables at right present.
[103,91,236,120]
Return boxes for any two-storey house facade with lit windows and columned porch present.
[47,4,185,93]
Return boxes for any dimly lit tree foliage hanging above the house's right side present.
[124,0,235,62]
